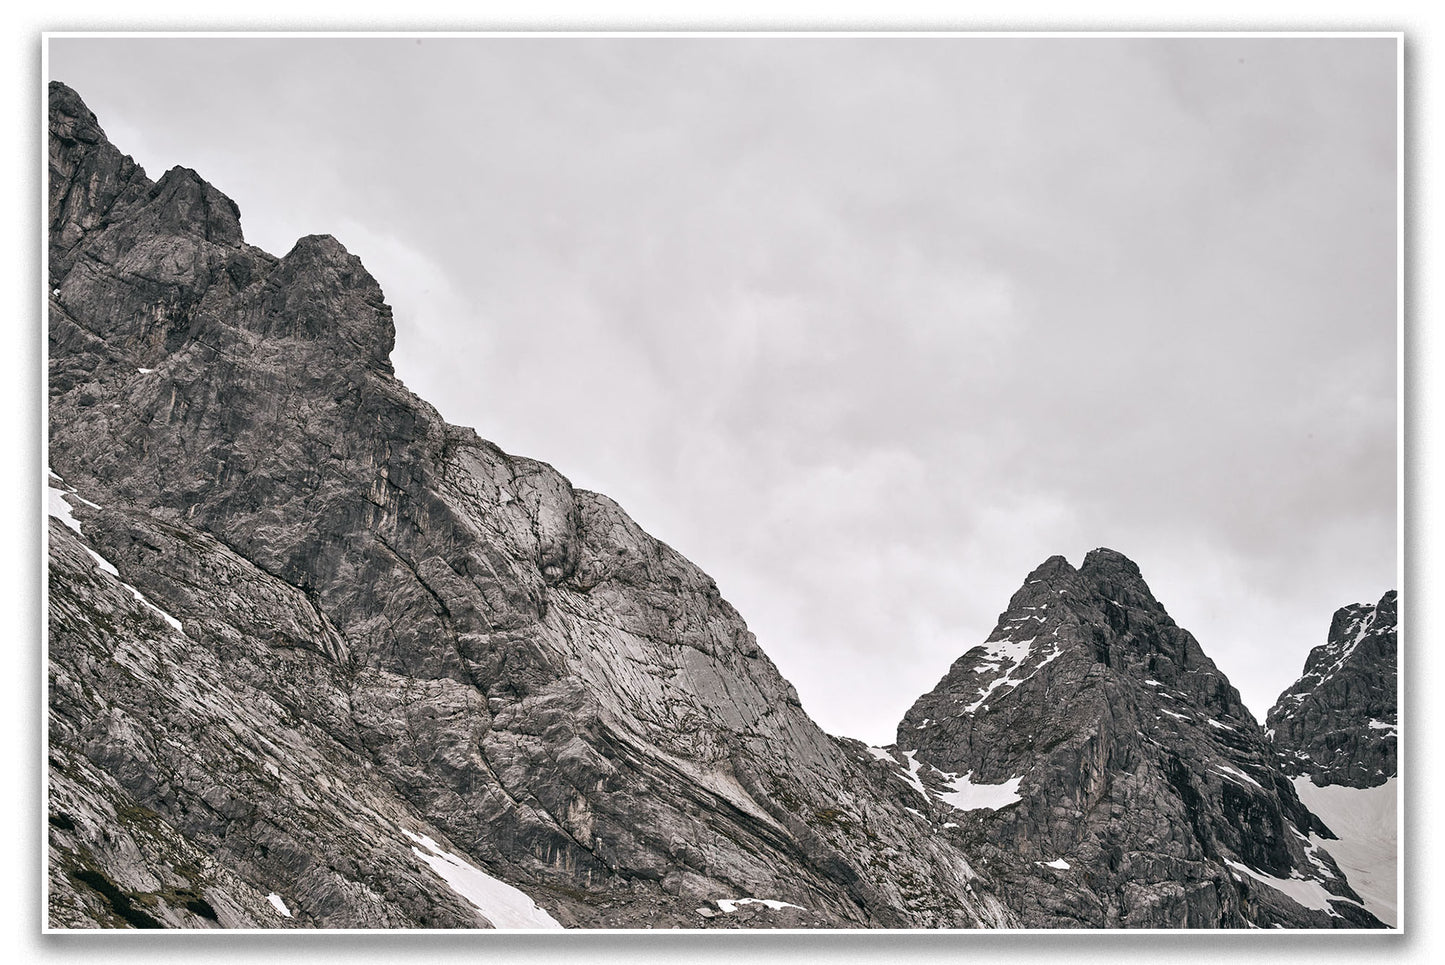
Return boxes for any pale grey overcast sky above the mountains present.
[49,38,1399,743]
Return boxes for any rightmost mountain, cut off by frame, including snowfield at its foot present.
[1264,589,1399,925]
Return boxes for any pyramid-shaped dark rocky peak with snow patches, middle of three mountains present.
[893,549,1380,927]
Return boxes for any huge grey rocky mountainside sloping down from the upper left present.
[48,84,1017,927]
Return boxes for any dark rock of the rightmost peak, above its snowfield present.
[1264,589,1399,787]
